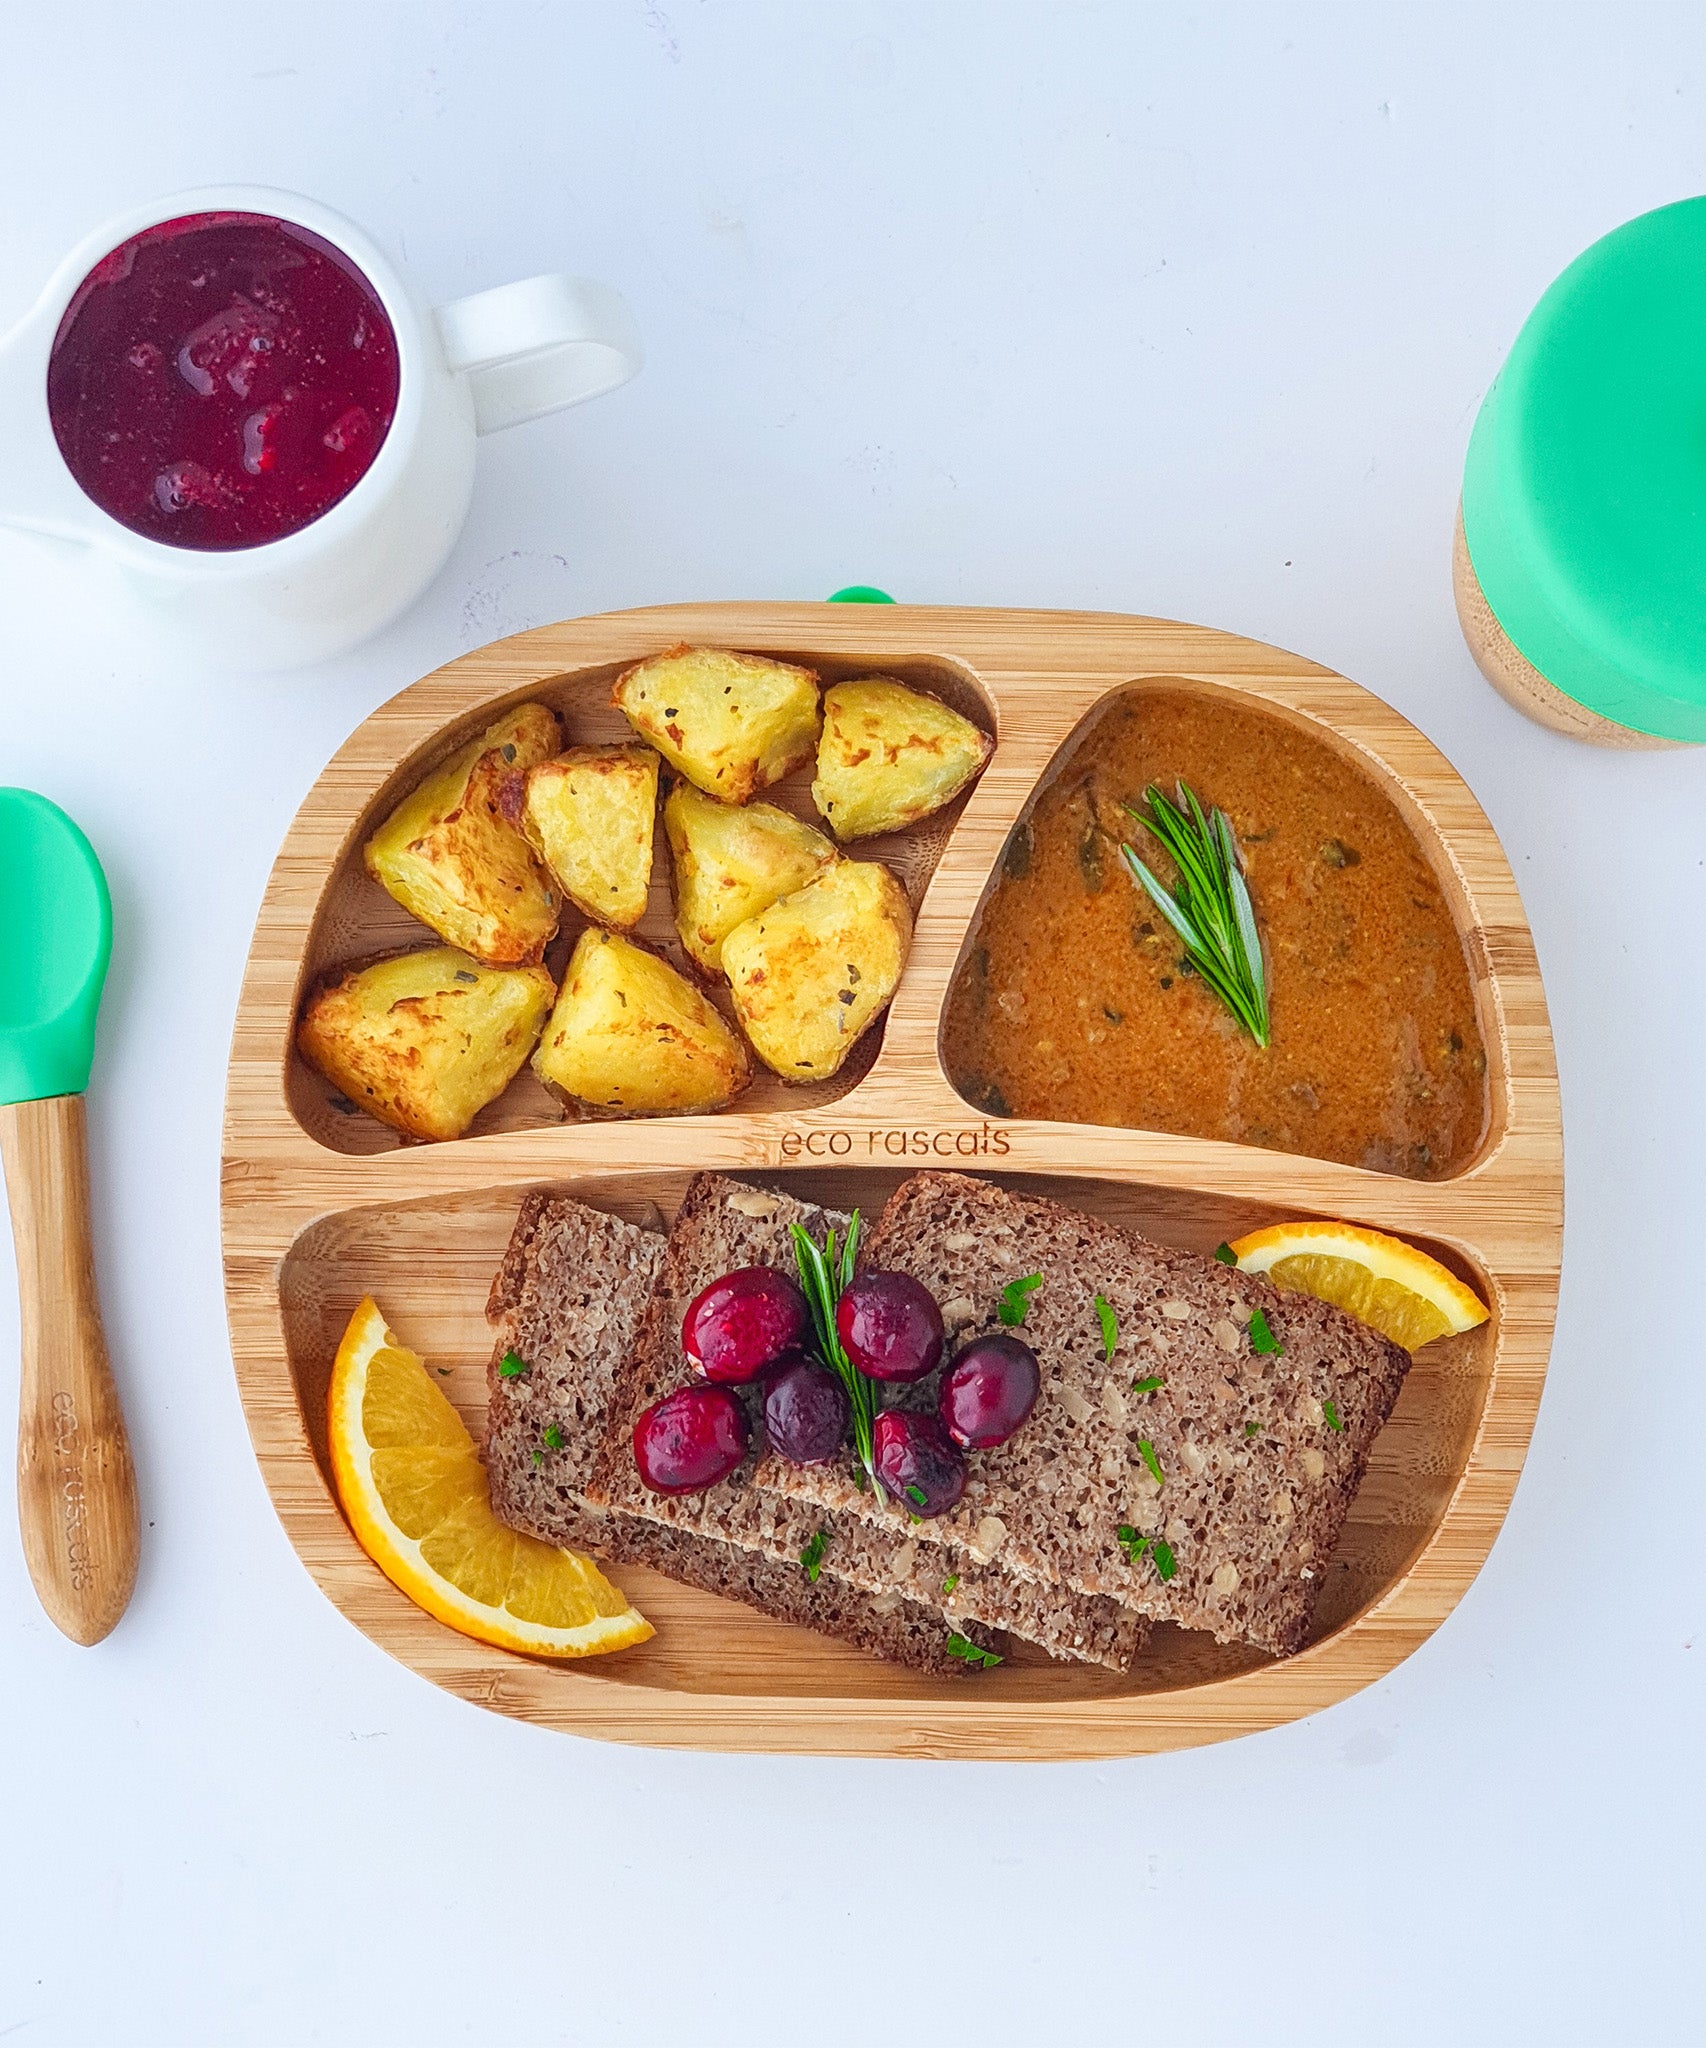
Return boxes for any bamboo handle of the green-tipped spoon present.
[0,1096,137,1642]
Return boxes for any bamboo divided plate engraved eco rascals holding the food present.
[223,604,1563,1757]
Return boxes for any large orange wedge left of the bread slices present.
[328,1298,653,1657]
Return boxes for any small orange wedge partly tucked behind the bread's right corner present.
[1229,1223,1487,1352]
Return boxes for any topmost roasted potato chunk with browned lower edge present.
[610,647,817,803]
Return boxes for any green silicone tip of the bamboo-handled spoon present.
[0,788,113,1102]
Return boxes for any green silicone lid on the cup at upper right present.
[1462,199,1706,739]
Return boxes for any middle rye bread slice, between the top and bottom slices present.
[586,1174,1149,1671]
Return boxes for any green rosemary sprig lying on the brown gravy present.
[1120,782,1268,1044]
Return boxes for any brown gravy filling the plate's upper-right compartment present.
[942,686,1489,1180]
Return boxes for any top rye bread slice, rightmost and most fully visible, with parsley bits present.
[758,1174,1409,1655]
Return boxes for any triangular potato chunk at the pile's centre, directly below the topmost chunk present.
[664,782,840,975]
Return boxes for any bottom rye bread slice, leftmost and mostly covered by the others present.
[485,1194,997,1675]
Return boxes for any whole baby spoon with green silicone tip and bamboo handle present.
[0,788,137,1642]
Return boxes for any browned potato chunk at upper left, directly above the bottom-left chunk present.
[362,705,563,967]
